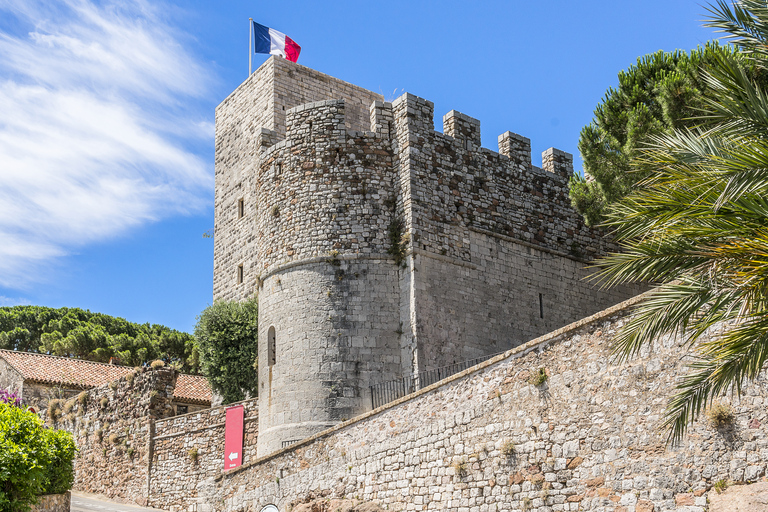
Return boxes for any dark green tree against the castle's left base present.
[195,299,258,404]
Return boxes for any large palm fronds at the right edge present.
[598,0,768,441]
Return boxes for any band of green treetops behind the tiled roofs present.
[0,306,198,373]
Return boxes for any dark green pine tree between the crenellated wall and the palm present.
[570,42,768,226]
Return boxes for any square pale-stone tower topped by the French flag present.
[213,57,382,300]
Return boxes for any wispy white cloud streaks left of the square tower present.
[0,0,213,289]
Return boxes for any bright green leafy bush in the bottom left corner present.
[0,403,76,512]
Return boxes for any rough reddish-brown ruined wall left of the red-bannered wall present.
[55,368,177,505]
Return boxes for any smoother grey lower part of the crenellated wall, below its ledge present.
[414,229,639,369]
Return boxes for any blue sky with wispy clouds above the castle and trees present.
[0,0,716,331]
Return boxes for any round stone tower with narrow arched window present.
[256,100,402,456]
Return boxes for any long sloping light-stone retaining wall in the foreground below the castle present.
[189,294,768,512]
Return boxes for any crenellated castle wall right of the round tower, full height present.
[393,94,641,370]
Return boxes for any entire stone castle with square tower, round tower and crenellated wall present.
[214,57,640,455]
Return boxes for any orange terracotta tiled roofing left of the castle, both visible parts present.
[0,350,211,403]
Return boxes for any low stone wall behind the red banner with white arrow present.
[149,399,259,510]
